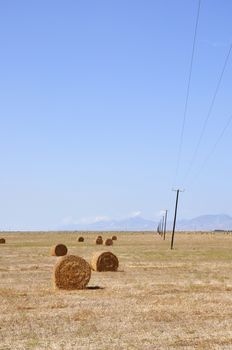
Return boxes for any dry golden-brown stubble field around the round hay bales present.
[0,232,232,350]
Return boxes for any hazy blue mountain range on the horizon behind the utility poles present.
[59,214,232,231]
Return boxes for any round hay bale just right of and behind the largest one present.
[91,252,119,272]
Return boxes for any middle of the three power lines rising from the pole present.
[183,43,232,182]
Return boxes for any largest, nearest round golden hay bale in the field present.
[53,255,91,290]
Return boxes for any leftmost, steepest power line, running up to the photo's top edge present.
[175,0,201,186]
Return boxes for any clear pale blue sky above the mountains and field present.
[0,0,232,229]
